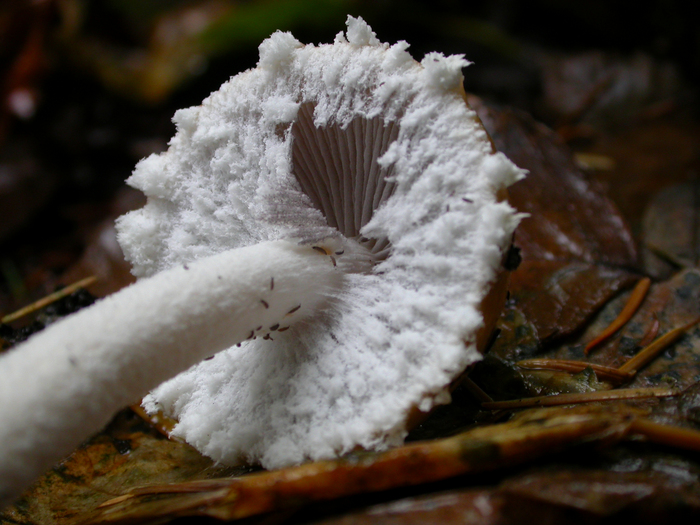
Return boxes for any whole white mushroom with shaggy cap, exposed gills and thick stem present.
[0,17,522,508]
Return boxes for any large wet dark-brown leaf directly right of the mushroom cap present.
[469,97,637,341]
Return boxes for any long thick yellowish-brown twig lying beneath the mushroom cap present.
[89,407,636,524]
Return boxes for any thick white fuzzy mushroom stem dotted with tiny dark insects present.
[0,241,343,507]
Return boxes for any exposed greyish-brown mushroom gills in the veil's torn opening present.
[292,102,399,263]
